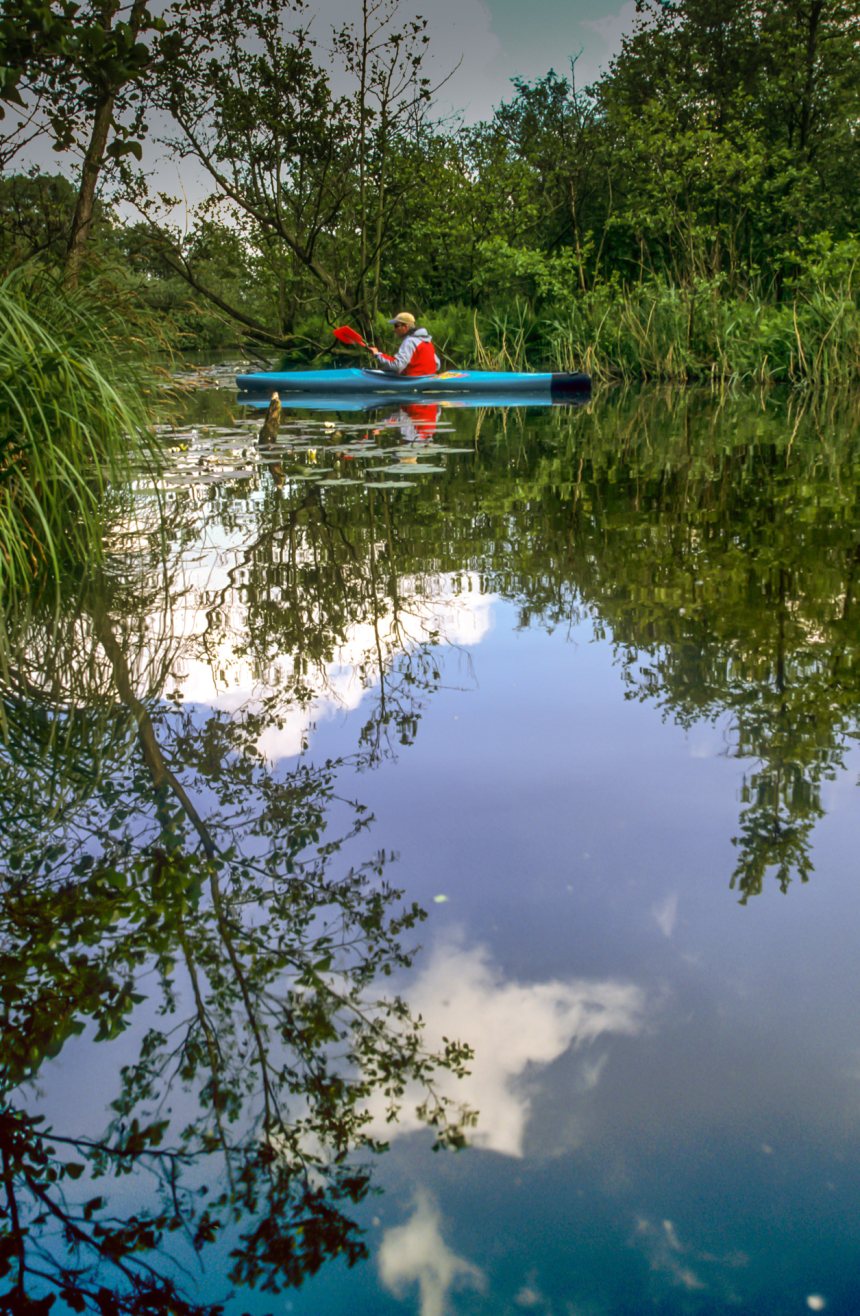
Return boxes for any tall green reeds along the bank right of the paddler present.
[428,272,860,387]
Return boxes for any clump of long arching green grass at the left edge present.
[0,275,162,599]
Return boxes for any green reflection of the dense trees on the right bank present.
[339,393,860,900]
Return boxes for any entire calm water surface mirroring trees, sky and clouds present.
[0,376,860,1316]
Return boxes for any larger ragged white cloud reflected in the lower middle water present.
[371,946,644,1155]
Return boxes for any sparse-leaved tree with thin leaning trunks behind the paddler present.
[132,0,442,343]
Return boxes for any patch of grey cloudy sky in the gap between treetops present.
[304,0,636,121]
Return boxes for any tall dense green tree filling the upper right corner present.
[598,0,860,290]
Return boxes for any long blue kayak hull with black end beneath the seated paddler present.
[236,368,591,397]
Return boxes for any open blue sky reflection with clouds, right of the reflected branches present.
[292,601,860,1316]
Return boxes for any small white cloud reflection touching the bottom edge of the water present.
[378,1190,485,1316]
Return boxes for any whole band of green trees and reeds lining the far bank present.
[0,0,860,365]
